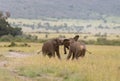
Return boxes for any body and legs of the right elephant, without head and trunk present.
[67,41,86,60]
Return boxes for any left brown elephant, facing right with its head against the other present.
[42,38,63,59]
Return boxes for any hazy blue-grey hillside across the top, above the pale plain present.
[0,0,120,19]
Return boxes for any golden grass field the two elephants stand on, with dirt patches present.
[0,42,120,81]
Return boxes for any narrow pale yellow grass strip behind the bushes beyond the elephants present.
[29,33,120,40]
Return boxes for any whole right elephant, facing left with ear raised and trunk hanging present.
[63,35,86,60]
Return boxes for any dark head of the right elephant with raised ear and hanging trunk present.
[63,35,79,54]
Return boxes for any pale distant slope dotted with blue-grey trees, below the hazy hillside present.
[8,18,120,35]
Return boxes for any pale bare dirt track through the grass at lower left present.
[0,51,36,81]
